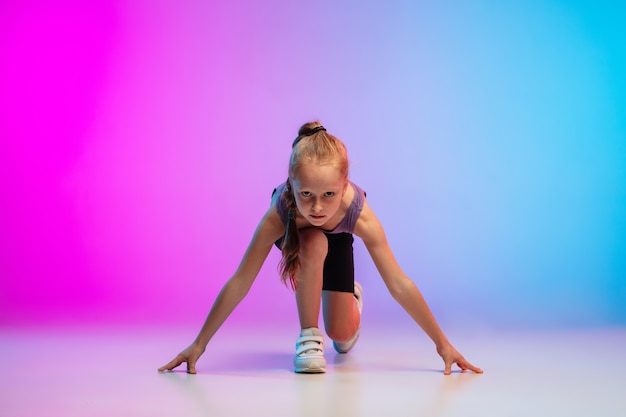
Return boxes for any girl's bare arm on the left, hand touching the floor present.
[159,204,285,374]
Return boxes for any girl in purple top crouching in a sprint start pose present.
[159,122,482,375]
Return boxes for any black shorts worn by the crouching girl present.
[276,233,354,293]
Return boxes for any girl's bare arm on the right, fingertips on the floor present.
[354,202,482,375]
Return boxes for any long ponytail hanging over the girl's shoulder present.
[279,180,300,290]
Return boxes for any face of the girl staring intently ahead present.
[291,162,348,227]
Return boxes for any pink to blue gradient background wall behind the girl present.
[0,0,626,328]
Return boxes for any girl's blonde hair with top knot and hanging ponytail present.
[279,121,349,290]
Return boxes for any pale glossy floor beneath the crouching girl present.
[0,323,626,417]
